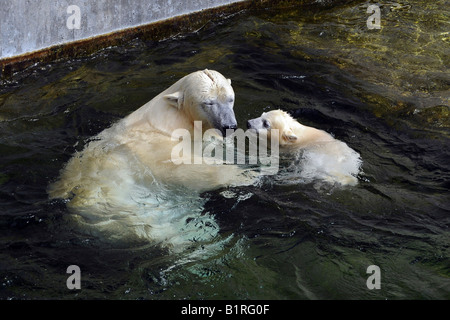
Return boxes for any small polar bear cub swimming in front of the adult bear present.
[247,110,362,186]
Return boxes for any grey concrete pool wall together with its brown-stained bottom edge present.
[0,0,351,78]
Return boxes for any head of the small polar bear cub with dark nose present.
[247,110,298,145]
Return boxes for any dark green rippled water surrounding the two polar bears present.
[0,1,450,299]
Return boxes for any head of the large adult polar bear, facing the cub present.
[164,69,237,136]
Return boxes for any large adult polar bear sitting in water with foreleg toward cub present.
[48,70,253,245]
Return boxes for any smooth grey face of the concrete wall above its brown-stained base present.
[0,0,241,60]
